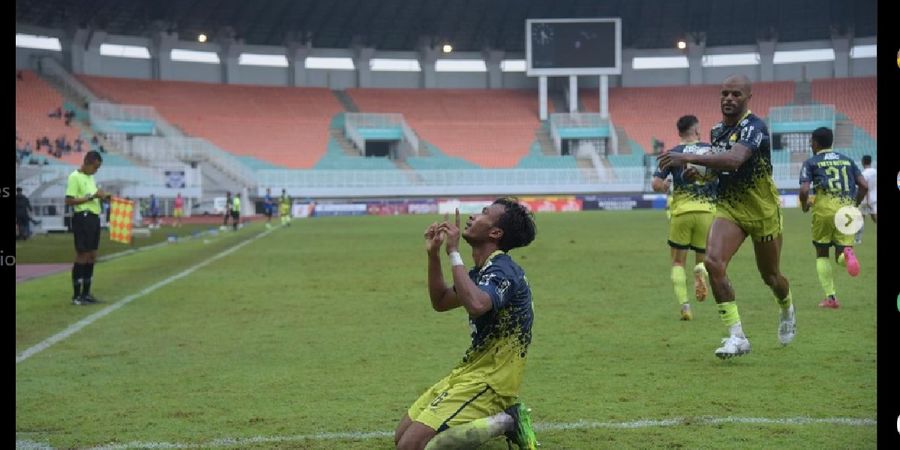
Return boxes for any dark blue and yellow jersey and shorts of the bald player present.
[710,110,781,240]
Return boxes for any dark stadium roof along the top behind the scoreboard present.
[16,0,877,52]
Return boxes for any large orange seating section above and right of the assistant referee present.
[79,76,341,169]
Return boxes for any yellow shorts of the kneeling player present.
[407,375,516,432]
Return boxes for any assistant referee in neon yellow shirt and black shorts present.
[66,151,110,305]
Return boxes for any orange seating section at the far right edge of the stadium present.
[812,77,878,139]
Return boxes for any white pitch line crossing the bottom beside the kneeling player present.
[10,416,877,450]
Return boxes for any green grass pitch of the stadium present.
[16,210,876,449]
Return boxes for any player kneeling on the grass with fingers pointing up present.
[394,198,537,450]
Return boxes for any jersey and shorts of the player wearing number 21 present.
[800,148,861,245]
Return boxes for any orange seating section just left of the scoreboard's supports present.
[347,89,540,168]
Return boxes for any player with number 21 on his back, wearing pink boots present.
[800,127,868,309]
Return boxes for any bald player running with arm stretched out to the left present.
[658,75,796,359]
